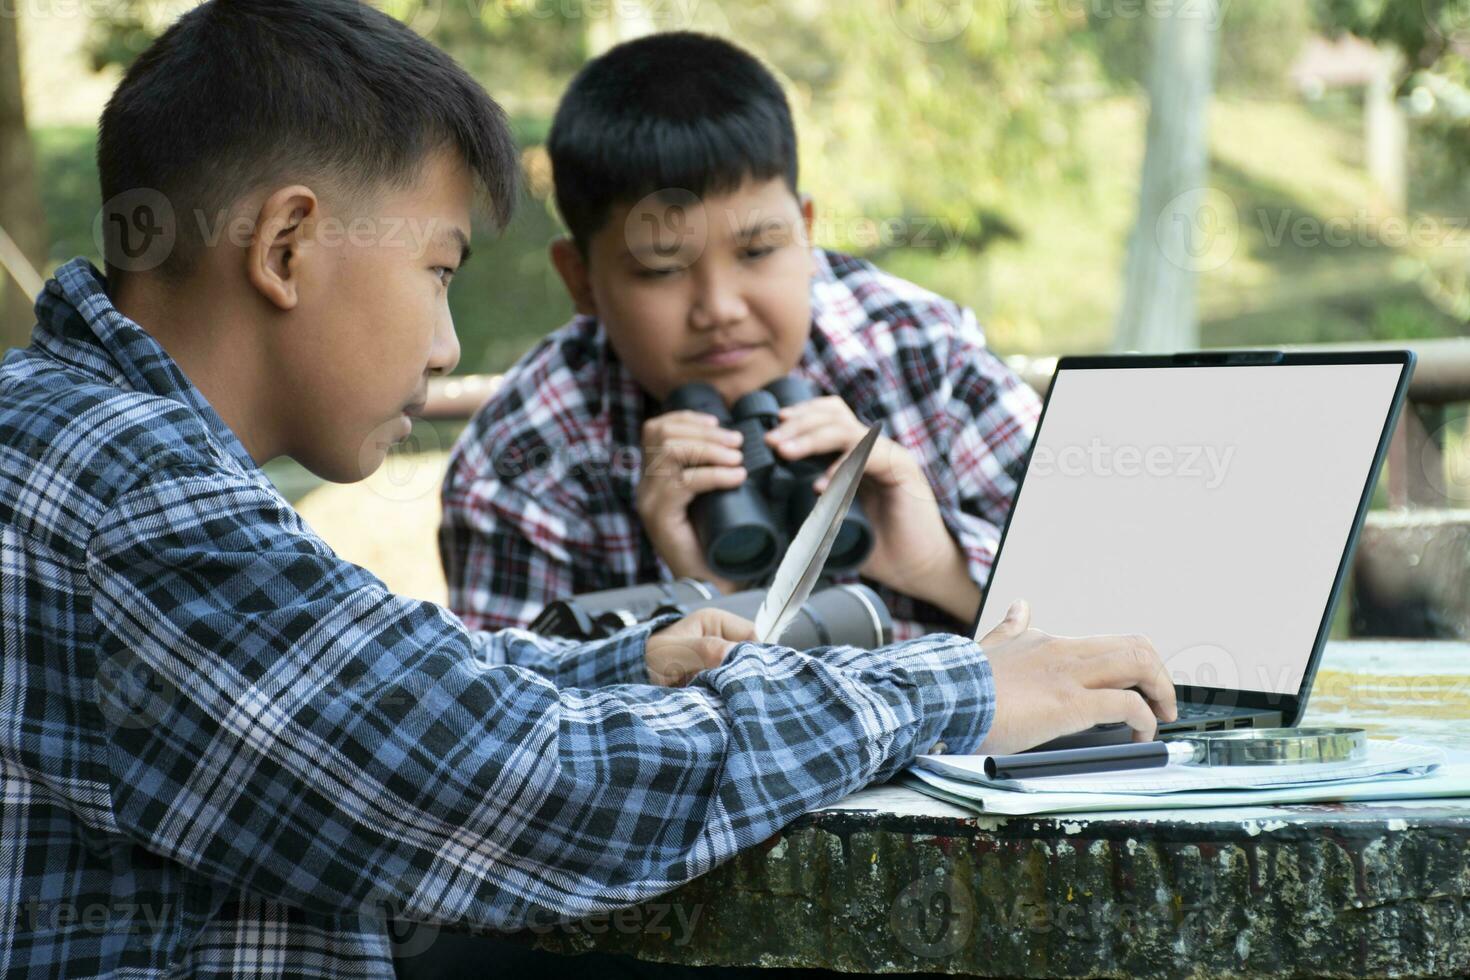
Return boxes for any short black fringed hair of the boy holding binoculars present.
[547,31,797,256]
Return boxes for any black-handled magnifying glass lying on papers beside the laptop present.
[985,727,1369,779]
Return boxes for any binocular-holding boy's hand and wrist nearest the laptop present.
[766,397,980,621]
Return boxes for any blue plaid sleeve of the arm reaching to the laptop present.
[88,467,994,929]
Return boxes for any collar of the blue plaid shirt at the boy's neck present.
[31,257,257,472]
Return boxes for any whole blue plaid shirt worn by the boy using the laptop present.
[0,260,994,977]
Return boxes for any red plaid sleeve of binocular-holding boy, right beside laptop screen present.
[931,310,1041,589]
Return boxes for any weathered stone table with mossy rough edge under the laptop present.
[535,642,1470,977]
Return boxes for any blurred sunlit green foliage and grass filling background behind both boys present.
[40,0,1470,372]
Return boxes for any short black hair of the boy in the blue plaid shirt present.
[97,0,519,279]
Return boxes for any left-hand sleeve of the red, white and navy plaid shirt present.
[440,457,597,629]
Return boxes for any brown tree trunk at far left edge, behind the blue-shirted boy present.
[0,10,47,350]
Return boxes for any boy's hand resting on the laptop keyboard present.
[979,601,1177,755]
